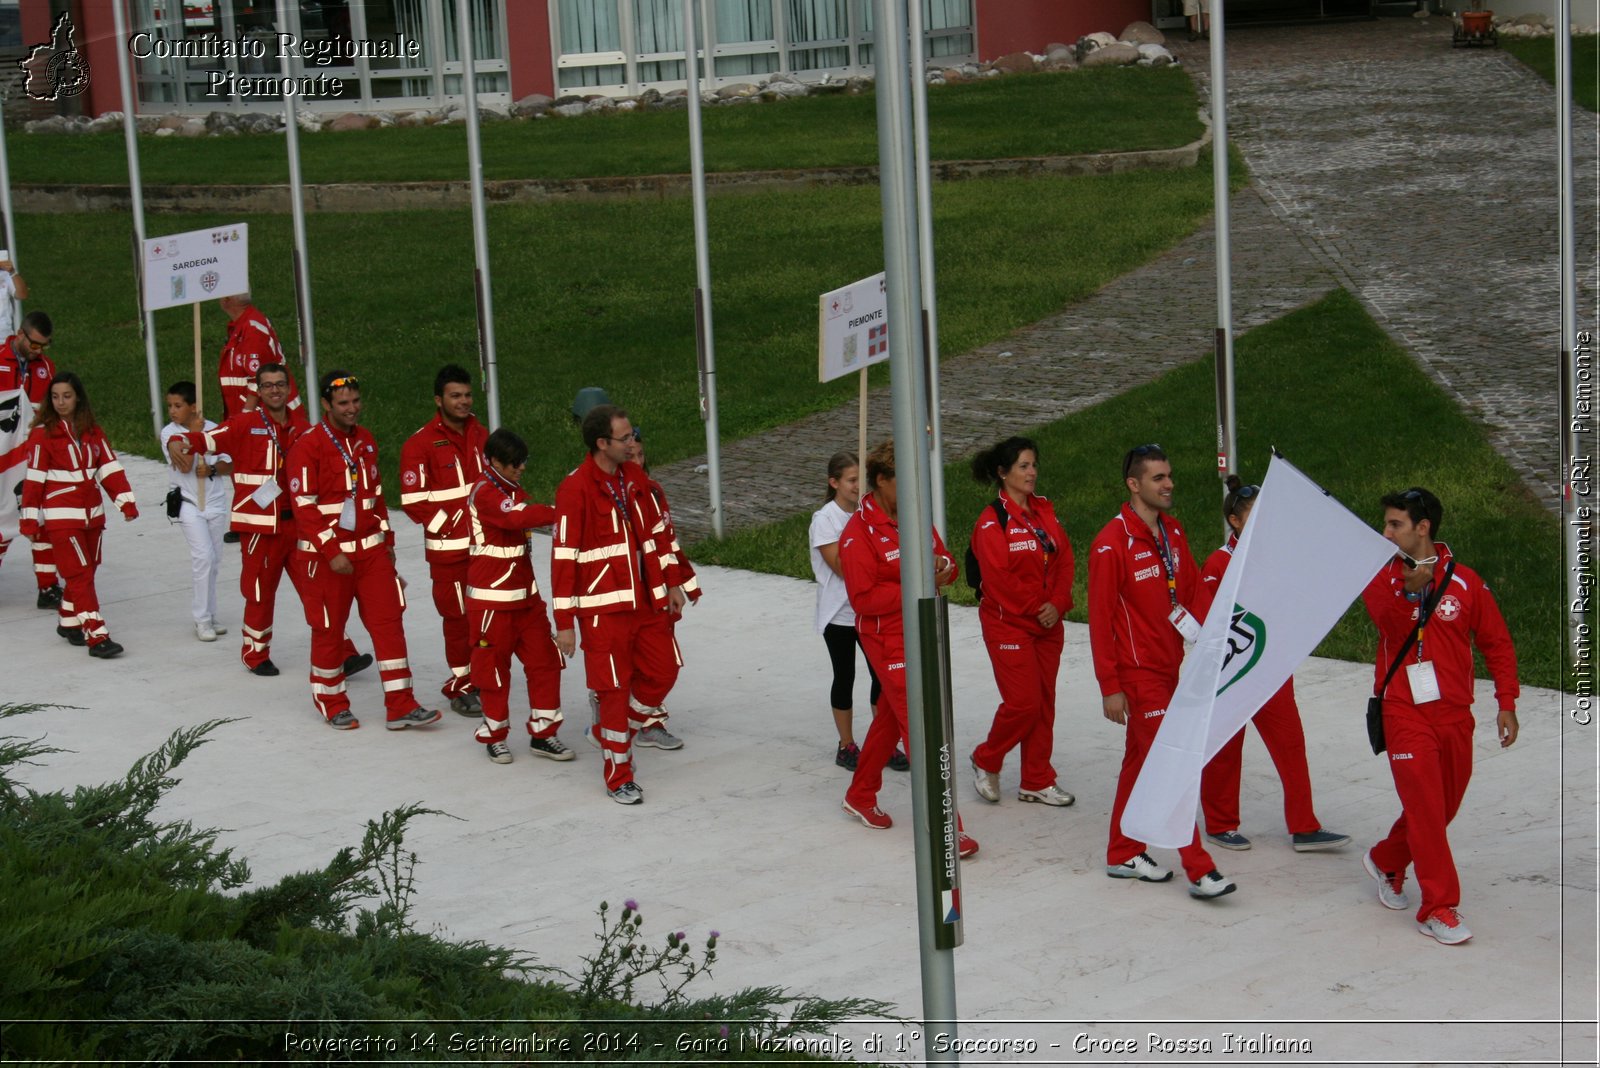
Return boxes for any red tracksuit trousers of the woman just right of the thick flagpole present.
[973,612,1066,790]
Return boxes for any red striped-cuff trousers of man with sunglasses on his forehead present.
[291,548,418,719]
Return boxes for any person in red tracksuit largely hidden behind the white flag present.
[1189,475,1350,852]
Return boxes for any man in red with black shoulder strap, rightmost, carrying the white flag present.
[1362,486,1522,945]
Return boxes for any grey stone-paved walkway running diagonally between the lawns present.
[656,18,1597,537]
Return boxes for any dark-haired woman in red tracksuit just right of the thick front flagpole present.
[971,436,1074,807]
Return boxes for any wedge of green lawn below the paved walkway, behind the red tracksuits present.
[691,291,1565,687]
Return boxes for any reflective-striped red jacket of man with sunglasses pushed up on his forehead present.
[288,420,394,561]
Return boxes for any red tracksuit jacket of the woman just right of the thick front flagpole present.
[971,494,1074,635]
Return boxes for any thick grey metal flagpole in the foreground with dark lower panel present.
[861,0,962,1063]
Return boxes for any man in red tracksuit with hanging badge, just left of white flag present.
[1090,444,1235,899]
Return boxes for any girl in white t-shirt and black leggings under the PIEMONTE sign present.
[811,451,910,771]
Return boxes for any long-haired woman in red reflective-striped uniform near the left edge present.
[21,371,139,660]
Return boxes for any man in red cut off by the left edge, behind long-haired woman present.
[0,312,61,611]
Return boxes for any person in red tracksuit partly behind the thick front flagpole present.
[838,441,978,857]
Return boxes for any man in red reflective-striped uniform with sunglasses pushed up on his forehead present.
[288,371,442,731]
